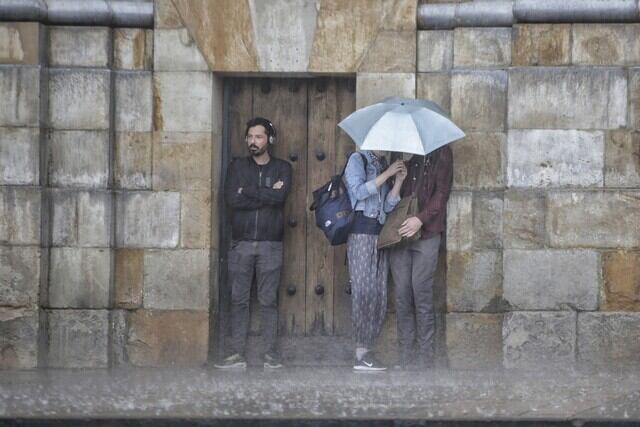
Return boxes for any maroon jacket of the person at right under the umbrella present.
[400,145,453,240]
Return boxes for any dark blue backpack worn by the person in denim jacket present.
[309,153,367,246]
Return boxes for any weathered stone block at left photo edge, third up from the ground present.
[0,187,42,245]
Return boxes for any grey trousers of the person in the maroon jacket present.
[389,236,440,361]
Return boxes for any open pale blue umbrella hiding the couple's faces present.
[338,97,465,155]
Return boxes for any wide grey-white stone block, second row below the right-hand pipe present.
[508,68,627,129]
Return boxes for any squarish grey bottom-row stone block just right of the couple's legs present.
[447,313,503,369]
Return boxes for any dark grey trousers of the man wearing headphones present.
[229,241,282,354]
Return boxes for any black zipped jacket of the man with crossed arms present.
[224,156,291,241]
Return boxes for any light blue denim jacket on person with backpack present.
[344,151,400,224]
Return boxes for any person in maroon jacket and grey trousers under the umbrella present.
[389,145,453,369]
